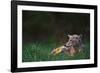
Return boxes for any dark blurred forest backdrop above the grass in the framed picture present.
[22,10,90,43]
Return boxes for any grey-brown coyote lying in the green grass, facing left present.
[51,34,84,56]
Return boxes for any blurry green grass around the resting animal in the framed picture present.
[22,40,90,62]
